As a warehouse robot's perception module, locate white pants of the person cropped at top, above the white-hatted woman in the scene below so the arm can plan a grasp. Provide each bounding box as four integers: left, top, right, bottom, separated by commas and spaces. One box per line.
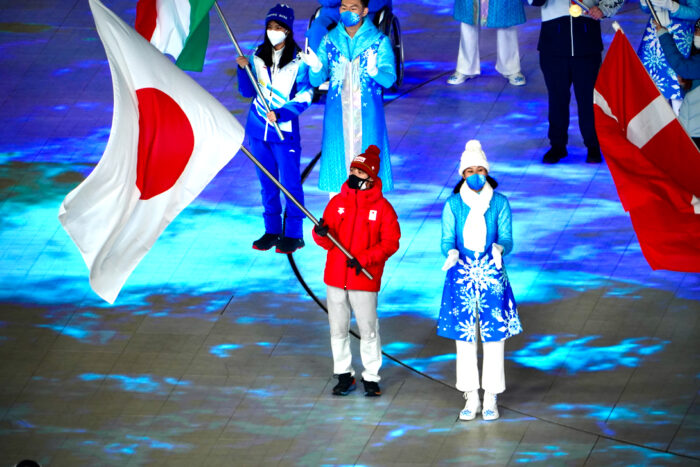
457, 23, 520, 76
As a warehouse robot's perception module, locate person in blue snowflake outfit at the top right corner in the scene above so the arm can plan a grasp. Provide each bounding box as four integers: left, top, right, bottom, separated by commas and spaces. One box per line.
637, 0, 700, 114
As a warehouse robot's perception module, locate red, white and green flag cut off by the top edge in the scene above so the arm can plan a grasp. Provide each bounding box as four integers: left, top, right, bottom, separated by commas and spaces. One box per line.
134, 0, 215, 71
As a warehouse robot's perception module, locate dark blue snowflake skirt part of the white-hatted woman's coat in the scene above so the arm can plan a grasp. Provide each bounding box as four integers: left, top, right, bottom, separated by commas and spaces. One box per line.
437, 250, 523, 342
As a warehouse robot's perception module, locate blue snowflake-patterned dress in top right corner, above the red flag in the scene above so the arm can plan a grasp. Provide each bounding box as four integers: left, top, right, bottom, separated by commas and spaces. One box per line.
637, 18, 695, 99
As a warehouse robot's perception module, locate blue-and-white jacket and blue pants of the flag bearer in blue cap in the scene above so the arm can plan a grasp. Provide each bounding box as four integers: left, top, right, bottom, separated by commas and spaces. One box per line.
238, 50, 313, 238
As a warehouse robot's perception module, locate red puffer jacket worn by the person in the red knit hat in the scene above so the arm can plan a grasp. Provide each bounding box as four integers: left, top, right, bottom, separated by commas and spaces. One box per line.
313, 179, 401, 292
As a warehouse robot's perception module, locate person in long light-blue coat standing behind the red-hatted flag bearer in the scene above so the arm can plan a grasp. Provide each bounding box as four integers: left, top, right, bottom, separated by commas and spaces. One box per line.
302, 0, 396, 193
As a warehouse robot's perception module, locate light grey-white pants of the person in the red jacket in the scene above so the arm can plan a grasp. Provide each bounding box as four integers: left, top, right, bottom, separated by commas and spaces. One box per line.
326, 286, 382, 382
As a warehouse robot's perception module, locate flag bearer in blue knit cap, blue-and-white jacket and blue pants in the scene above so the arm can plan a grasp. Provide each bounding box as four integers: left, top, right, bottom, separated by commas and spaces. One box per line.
236, 4, 313, 253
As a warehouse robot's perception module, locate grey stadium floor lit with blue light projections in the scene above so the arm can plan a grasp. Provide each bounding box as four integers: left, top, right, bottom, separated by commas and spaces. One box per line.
0, 0, 700, 466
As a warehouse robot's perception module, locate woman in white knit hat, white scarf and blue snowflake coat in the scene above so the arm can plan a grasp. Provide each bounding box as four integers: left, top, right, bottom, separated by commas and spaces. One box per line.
437, 140, 522, 420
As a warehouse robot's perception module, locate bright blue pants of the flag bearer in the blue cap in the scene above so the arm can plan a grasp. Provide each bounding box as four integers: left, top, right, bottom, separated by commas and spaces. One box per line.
250, 137, 304, 238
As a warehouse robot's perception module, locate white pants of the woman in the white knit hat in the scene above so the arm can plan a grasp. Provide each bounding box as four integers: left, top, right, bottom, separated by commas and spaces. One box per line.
455, 340, 506, 394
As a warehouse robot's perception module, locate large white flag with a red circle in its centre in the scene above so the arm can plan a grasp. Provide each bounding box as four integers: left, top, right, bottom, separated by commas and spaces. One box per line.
58, 0, 243, 303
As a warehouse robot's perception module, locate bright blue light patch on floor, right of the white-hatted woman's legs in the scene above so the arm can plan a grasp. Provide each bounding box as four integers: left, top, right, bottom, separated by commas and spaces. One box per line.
507, 335, 669, 374
